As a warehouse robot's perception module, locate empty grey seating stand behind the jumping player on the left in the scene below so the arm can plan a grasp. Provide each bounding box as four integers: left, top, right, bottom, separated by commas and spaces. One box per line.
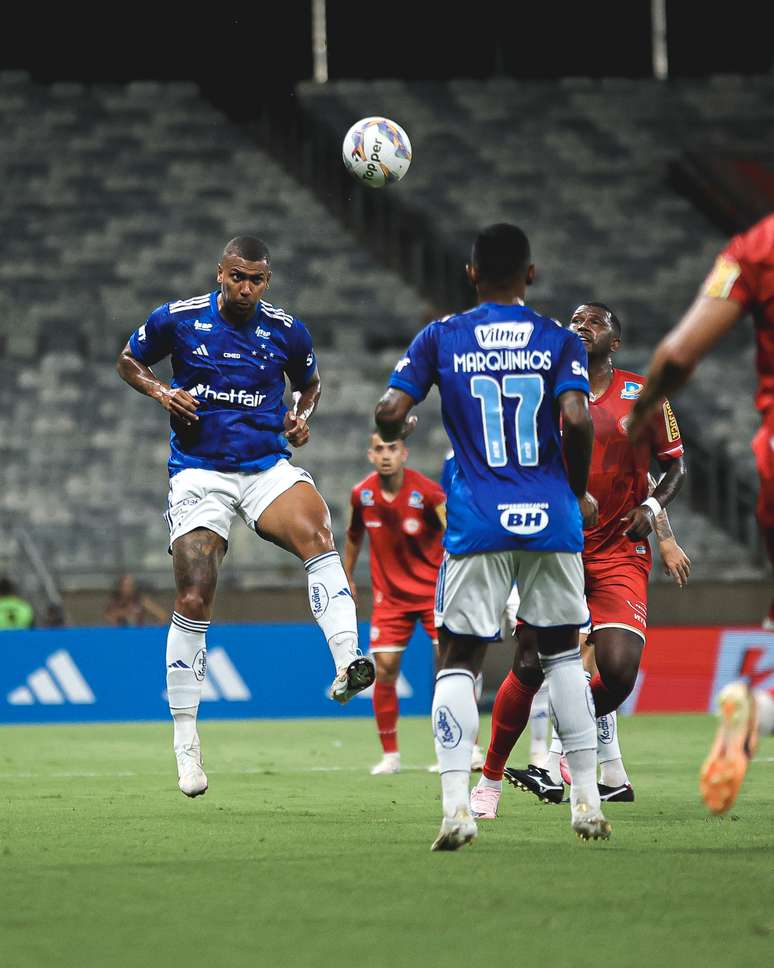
0, 73, 436, 587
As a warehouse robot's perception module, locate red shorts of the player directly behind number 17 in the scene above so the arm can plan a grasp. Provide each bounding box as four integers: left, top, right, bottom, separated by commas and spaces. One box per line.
583, 558, 650, 640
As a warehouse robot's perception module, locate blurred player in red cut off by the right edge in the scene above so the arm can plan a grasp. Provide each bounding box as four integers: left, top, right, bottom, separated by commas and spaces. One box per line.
629, 213, 774, 813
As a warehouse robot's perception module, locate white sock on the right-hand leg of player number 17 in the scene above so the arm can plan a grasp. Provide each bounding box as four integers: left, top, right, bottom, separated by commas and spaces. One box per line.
538, 648, 599, 809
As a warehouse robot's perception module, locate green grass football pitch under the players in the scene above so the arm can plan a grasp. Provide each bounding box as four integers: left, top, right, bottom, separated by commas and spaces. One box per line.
0, 716, 774, 968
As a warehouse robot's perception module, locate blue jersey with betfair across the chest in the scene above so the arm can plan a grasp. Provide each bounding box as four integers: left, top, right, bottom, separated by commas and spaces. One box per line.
129, 291, 317, 476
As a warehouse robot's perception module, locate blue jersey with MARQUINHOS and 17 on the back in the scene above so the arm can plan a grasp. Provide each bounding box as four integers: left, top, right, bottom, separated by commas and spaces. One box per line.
389, 303, 589, 554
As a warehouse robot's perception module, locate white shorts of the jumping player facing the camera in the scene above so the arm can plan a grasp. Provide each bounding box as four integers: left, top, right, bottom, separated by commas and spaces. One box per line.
164, 459, 314, 548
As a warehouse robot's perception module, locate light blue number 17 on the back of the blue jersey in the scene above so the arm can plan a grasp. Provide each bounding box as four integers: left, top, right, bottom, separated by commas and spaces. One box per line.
470, 373, 544, 467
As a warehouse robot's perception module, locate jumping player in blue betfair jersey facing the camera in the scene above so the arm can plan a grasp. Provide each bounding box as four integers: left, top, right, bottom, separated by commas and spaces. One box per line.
117, 236, 375, 797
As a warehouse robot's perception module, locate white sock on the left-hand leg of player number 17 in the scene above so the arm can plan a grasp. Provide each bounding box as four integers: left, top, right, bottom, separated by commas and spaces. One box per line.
433, 669, 478, 817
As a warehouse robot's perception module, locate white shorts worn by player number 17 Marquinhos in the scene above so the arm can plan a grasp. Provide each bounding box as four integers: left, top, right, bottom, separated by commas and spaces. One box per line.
435, 551, 590, 641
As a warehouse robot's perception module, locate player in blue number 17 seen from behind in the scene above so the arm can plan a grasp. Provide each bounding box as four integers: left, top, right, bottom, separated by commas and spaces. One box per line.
375, 224, 610, 850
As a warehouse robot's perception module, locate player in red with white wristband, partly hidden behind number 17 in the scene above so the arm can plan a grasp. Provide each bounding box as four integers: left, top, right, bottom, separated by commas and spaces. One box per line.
472, 303, 690, 819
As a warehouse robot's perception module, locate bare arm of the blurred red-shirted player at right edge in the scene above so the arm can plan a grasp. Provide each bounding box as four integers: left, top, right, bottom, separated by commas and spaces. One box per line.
629, 296, 742, 440
